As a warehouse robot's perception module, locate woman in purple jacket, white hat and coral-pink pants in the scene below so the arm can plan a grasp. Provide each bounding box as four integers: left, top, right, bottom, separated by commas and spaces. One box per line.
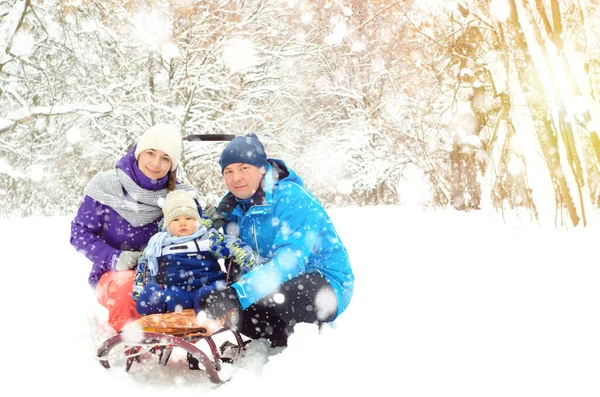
71, 124, 195, 332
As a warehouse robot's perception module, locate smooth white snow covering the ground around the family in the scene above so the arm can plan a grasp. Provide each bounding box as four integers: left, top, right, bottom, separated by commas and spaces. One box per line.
0, 206, 600, 397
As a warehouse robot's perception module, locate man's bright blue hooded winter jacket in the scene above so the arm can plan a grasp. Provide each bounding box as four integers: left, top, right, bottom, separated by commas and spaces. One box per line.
219, 159, 354, 317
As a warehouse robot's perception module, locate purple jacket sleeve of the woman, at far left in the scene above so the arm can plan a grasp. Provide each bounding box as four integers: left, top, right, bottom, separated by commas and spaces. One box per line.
71, 196, 121, 274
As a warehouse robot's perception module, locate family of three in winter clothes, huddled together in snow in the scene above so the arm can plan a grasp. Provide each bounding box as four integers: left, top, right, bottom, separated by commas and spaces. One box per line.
70, 124, 354, 347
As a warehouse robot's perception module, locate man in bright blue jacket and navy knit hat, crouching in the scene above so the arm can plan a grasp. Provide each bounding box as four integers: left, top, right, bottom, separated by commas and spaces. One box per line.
196, 133, 354, 347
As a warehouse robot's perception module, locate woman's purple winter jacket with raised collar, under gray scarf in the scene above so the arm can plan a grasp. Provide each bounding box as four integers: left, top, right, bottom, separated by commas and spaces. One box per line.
71, 146, 168, 288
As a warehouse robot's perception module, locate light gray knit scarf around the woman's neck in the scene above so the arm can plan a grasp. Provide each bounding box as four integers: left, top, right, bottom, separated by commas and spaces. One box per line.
85, 168, 196, 226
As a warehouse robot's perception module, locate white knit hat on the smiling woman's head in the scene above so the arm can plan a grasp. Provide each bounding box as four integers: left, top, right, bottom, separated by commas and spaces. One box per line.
135, 124, 181, 171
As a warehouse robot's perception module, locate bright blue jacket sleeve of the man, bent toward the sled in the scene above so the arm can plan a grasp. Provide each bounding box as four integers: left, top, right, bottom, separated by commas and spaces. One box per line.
232, 183, 324, 309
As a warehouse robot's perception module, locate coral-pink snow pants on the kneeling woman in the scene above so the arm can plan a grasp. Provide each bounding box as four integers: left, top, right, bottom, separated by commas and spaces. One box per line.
96, 270, 141, 332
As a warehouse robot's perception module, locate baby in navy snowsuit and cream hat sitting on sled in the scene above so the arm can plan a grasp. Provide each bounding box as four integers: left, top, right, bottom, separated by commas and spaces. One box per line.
133, 190, 261, 316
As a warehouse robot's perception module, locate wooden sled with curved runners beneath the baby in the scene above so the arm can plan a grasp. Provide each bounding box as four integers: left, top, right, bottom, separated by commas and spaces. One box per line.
97, 309, 245, 383
